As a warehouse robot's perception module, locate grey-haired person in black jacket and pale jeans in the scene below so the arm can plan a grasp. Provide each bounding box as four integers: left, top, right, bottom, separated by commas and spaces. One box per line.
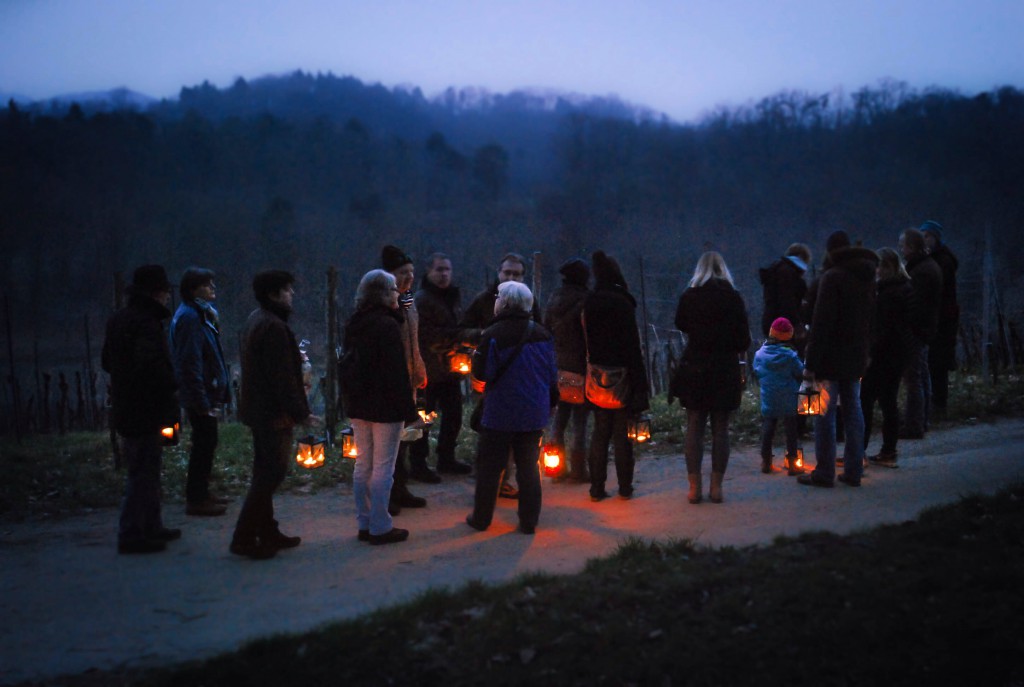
344, 269, 419, 545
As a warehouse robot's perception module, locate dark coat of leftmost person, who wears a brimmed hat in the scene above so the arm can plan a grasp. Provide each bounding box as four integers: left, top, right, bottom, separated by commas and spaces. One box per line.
102, 294, 180, 437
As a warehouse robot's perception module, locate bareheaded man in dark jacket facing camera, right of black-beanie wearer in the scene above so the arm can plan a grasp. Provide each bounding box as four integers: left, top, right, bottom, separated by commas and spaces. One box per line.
409, 253, 482, 483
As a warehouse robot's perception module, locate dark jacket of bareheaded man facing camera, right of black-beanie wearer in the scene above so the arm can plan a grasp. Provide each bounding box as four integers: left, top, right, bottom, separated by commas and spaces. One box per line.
416, 276, 479, 384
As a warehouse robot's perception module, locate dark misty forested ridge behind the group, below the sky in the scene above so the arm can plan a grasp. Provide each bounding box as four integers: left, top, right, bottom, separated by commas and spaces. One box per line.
0, 72, 1024, 364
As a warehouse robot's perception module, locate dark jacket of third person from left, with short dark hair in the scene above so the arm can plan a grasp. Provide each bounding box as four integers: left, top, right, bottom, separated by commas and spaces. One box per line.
239, 303, 309, 429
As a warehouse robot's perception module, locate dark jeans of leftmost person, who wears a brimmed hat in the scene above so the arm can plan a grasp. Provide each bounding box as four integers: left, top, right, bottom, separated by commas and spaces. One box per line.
118, 433, 164, 543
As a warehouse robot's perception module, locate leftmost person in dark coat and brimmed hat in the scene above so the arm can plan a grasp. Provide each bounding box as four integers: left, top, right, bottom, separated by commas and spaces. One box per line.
102, 265, 181, 554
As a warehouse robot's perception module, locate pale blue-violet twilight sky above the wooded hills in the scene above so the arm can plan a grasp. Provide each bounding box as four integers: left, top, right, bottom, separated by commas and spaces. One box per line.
0, 0, 1024, 121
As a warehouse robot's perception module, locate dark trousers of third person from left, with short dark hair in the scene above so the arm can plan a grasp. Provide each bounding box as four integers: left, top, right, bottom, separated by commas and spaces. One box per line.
231, 427, 292, 544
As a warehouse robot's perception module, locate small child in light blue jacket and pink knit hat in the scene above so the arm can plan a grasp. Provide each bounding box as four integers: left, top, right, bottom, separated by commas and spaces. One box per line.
754, 317, 804, 475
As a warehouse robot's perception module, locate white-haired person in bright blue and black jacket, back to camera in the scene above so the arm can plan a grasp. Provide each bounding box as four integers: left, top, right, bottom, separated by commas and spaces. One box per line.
466, 282, 558, 534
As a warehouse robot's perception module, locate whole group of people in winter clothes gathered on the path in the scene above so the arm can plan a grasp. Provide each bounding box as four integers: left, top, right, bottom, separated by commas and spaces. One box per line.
102, 220, 958, 559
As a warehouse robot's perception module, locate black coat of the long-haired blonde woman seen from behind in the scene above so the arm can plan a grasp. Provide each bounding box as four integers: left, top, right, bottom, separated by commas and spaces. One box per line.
676, 278, 751, 411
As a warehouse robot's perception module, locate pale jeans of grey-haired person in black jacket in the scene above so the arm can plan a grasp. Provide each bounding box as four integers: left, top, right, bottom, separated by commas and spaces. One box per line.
352, 419, 404, 534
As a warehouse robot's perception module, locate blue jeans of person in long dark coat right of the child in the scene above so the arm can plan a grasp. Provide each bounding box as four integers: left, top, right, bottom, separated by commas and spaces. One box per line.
812, 379, 864, 482
